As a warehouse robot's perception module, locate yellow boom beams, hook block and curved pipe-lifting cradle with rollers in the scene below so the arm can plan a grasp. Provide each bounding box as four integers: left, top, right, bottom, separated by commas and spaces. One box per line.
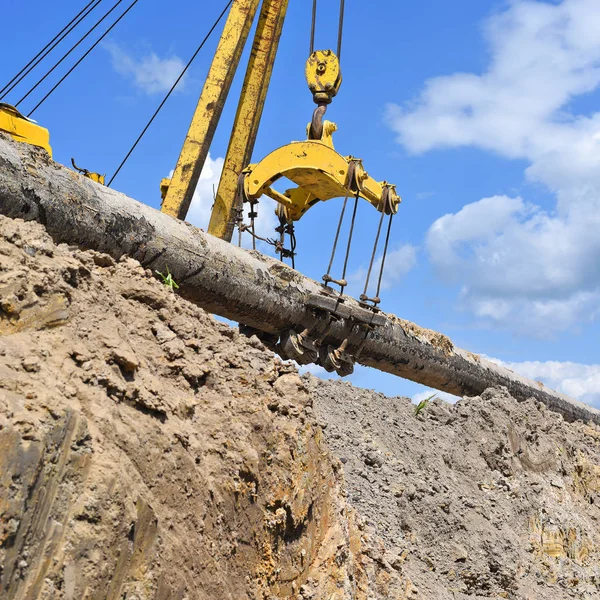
160, 0, 400, 375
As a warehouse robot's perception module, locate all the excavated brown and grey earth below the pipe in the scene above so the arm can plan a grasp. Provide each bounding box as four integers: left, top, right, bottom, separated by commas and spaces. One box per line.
0, 217, 600, 600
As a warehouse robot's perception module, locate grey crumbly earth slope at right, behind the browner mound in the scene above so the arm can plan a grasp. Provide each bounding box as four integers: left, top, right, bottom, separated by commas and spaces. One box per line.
304, 376, 600, 600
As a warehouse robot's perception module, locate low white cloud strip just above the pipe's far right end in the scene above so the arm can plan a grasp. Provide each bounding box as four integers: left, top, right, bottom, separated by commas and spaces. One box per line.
486, 357, 600, 406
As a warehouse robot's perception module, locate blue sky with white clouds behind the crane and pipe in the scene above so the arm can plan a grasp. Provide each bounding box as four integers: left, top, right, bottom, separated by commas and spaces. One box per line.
0, 0, 600, 405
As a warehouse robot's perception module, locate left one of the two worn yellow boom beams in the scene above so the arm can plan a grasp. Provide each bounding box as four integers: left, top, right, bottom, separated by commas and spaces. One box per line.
161, 0, 259, 219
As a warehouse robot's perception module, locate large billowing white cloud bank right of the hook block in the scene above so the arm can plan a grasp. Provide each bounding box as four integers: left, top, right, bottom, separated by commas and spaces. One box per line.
388, 0, 600, 334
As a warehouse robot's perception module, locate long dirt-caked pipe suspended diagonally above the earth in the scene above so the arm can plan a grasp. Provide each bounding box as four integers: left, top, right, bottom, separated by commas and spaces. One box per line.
0, 134, 600, 423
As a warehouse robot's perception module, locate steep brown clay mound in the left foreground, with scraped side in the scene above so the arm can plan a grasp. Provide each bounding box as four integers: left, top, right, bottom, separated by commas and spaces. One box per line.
0, 217, 405, 600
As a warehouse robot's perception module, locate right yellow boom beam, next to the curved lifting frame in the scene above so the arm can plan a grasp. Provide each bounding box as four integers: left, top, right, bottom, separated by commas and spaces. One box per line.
208, 0, 288, 241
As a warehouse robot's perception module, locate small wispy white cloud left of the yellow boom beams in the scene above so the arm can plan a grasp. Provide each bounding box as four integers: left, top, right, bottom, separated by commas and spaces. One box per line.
103, 42, 185, 94
